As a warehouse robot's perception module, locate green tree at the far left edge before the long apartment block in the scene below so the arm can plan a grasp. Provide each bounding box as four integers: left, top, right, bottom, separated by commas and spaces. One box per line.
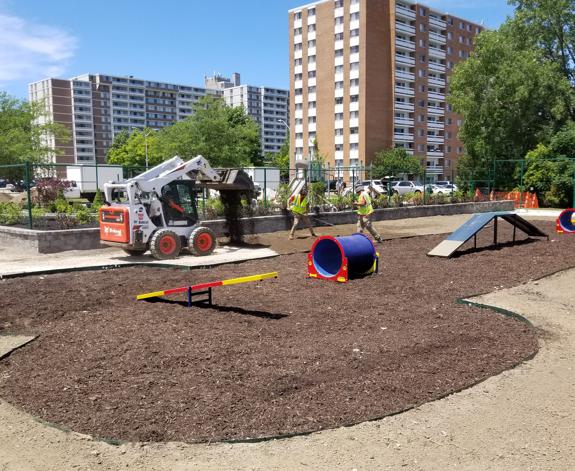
0, 92, 70, 165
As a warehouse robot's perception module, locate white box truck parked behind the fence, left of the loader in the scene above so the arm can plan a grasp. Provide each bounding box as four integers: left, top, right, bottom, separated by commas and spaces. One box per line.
65, 165, 124, 198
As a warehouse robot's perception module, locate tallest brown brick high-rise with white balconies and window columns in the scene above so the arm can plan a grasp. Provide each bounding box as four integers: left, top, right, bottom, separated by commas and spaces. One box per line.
289, 0, 482, 180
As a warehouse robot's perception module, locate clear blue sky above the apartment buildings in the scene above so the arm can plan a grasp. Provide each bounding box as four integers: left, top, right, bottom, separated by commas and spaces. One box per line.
0, 0, 512, 98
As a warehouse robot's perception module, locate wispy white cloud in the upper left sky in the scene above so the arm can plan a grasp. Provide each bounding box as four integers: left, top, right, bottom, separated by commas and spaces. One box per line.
0, 13, 76, 83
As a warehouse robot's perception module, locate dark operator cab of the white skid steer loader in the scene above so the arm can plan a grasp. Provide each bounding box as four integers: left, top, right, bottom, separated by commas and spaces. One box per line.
161, 180, 198, 227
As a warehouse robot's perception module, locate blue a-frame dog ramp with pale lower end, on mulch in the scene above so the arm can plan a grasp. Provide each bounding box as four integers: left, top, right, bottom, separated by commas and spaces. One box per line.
427, 211, 549, 257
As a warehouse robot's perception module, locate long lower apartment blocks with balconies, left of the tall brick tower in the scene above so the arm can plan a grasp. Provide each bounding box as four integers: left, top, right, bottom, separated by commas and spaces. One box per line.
28, 74, 289, 164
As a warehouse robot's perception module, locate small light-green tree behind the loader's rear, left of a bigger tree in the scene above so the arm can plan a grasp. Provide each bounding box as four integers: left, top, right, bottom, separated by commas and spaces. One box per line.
107, 128, 164, 167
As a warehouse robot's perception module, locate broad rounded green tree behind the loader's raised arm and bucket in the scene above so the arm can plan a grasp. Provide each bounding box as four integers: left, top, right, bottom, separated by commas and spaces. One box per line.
159, 96, 262, 167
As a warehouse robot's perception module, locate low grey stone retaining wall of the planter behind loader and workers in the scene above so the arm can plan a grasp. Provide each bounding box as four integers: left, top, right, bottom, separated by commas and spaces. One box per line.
0, 201, 514, 253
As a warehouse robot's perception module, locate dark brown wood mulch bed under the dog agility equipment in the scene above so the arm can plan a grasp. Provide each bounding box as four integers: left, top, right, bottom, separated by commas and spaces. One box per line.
0, 222, 575, 442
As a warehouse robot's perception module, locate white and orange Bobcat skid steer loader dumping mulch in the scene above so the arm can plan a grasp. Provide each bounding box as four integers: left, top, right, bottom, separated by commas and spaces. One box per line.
100, 156, 254, 260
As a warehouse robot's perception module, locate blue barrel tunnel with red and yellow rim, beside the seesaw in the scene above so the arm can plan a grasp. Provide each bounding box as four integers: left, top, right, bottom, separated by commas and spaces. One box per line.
307, 233, 379, 283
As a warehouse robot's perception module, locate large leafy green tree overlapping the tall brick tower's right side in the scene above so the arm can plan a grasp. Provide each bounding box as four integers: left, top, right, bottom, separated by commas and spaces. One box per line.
448, 24, 572, 181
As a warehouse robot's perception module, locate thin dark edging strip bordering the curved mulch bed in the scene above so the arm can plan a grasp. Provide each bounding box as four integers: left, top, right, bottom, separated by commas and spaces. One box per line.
0, 254, 573, 446
